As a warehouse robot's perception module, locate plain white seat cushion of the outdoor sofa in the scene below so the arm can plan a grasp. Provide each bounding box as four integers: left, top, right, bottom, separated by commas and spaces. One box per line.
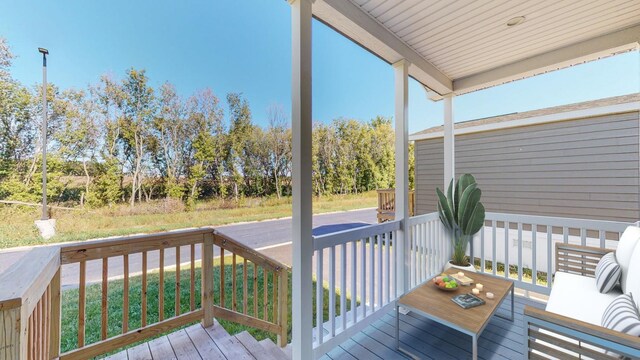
546, 271, 621, 326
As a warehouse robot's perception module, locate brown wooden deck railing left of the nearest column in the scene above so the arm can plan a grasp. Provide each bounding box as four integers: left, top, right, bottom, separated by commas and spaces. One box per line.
0, 228, 289, 360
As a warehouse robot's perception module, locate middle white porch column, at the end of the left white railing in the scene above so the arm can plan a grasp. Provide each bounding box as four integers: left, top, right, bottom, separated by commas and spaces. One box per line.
393, 59, 409, 295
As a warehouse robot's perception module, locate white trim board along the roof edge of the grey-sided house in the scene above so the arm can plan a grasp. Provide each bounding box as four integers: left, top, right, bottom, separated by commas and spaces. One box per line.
409, 101, 640, 141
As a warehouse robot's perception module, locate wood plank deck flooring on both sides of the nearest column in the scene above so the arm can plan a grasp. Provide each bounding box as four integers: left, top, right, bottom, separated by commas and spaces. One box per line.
104, 296, 544, 360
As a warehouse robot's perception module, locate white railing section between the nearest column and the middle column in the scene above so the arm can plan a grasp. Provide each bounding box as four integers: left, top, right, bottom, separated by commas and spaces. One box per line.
313, 221, 400, 358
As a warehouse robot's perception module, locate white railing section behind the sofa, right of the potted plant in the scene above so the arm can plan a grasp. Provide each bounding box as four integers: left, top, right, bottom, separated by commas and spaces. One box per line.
469, 213, 633, 294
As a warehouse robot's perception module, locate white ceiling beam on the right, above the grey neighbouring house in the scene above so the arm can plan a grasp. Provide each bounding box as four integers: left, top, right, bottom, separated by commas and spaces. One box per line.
452, 25, 640, 99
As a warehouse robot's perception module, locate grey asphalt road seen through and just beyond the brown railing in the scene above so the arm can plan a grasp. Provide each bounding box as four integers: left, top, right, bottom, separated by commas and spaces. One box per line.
57, 209, 376, 288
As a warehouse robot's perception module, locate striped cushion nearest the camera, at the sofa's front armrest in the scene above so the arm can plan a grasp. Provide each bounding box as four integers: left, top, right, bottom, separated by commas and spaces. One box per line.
602, 294, 640, 336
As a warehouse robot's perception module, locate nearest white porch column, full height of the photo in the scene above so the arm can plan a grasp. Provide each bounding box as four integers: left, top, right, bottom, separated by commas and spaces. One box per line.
290, 0, 313, 359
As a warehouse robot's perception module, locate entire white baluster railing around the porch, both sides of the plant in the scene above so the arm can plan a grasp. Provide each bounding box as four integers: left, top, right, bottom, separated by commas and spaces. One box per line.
313, 212, 633, 358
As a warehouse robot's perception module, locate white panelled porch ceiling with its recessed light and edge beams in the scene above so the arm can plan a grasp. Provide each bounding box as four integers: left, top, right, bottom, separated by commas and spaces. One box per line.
313, 0, 640, 95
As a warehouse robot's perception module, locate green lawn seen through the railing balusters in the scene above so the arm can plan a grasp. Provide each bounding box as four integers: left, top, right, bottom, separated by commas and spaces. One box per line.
61, 259, 351, 352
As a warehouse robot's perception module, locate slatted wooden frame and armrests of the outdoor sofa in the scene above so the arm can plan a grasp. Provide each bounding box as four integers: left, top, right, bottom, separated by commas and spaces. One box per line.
524, 243, 640, 360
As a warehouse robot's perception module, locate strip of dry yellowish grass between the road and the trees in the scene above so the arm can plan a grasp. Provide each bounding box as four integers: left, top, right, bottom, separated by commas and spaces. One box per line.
0, 191, 377, 248
